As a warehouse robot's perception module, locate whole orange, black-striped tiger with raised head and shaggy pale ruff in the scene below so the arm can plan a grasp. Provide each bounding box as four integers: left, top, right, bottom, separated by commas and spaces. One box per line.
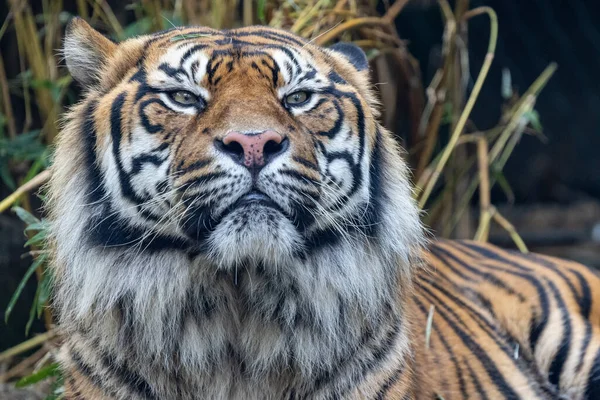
47, 18, 600, 400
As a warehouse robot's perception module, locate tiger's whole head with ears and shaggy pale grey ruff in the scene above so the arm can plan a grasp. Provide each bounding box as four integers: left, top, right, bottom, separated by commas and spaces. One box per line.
49, 19, 423, 388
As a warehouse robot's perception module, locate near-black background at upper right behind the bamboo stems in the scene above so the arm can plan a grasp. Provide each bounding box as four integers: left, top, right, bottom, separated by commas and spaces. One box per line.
396, 0, 600, 204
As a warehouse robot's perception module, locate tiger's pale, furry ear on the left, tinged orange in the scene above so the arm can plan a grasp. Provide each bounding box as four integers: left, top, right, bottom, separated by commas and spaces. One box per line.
63, 17, 117, 87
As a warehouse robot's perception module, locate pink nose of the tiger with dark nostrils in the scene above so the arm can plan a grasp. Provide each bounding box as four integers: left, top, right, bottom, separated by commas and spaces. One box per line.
217, 130, 289, 168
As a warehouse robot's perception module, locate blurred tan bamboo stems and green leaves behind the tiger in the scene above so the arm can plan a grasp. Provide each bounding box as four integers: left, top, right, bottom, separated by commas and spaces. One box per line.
0, 0, 556, 398
